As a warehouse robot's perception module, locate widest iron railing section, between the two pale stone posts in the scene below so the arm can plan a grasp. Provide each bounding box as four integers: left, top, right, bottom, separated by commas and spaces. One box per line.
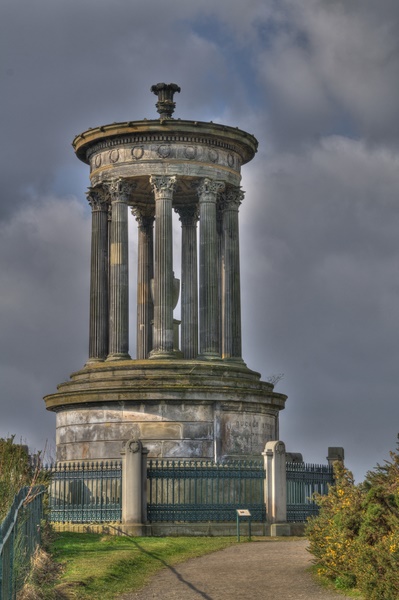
147, 460, 266, 523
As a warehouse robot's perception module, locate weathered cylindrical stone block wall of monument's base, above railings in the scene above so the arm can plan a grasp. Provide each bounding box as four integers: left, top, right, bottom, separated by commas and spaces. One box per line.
56, 402, 277, 461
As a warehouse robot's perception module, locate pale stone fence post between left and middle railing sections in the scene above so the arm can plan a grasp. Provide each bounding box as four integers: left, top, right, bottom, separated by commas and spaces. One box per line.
121, 439, 143, 535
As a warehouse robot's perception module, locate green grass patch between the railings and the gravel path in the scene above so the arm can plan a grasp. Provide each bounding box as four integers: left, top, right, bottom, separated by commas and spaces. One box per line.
50, 533, 235, 600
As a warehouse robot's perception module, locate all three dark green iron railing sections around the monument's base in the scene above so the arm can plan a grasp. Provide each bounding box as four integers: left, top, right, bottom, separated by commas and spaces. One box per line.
46, 459, 334, 523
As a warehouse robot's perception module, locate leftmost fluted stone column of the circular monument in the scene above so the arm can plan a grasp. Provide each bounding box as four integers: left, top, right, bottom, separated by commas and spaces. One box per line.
87, 187, 109, 364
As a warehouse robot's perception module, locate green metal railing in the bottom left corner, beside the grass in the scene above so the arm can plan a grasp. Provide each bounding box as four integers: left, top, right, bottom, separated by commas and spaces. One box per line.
0, 486, 46, 600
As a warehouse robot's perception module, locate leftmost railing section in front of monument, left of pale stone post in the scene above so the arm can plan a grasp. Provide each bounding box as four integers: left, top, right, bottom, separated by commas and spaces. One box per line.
44, 461, 122, 523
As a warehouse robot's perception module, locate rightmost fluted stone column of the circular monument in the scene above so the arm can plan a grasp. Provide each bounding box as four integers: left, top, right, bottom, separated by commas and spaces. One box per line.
222, 189, 244, 362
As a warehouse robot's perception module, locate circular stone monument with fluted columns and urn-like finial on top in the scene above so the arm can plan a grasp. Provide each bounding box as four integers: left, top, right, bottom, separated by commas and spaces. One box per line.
45, 83, 286, 461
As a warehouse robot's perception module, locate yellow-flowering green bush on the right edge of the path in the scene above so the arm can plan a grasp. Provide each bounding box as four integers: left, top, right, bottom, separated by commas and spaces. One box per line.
307, 453, 399, 600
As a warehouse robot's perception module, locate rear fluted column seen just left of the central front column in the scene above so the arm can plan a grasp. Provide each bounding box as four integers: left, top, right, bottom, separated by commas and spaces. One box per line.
132, 205, 154, 360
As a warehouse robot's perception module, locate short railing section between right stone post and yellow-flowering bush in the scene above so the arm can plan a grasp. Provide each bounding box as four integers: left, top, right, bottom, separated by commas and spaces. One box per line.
286, 463, 334, 523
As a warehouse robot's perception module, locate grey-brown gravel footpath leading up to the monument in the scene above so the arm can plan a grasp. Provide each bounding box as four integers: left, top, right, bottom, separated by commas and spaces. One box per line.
120, 539, 356, 600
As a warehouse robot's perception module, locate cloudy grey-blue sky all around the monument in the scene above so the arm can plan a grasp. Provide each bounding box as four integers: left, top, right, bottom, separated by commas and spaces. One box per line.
0, 0, 399, 481
